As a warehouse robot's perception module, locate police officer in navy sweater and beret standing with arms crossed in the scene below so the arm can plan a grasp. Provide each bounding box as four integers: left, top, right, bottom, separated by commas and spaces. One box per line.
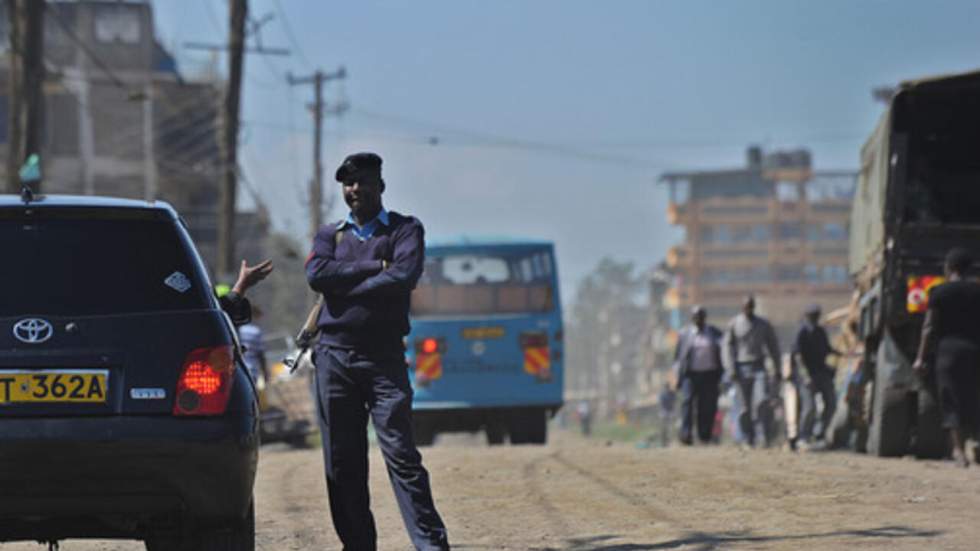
306, 153, 449, 551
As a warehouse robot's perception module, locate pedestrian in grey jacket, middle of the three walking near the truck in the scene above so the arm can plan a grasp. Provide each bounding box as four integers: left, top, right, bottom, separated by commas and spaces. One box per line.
725, 295, 782, 446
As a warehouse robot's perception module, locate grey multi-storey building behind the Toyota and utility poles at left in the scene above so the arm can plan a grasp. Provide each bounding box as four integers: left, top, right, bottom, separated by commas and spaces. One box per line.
0, 0, 268, 272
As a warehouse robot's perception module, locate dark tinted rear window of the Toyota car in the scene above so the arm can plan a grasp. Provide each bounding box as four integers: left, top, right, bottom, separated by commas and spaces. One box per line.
0, 209, 209, 316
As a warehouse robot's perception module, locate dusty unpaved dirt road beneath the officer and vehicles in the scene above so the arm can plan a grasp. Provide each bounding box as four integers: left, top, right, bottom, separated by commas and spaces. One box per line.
0, 433, 980, 551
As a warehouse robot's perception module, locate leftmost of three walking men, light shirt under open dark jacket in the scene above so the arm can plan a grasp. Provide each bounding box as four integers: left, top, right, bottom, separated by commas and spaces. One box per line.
674, 306, 724, 445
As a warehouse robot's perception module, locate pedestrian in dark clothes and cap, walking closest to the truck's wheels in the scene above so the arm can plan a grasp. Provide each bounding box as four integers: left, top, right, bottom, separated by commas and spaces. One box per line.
790, 304, 841, 445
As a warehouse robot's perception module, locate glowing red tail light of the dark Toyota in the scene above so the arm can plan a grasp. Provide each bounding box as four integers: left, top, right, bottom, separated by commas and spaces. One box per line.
174, 346, 235, 415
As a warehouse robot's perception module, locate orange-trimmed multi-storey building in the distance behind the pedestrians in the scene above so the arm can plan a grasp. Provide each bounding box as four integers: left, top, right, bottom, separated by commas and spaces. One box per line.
660, 147, 856, 343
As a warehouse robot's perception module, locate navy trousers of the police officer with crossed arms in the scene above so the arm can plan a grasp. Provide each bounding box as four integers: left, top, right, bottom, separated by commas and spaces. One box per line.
314, 343, 449, 551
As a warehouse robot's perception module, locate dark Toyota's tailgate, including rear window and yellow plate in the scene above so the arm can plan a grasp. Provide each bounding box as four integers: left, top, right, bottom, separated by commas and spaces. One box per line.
0, 206, 224, 418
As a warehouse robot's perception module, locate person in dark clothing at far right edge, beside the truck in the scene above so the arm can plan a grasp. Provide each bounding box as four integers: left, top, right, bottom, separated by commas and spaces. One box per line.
913, 249, 980, 467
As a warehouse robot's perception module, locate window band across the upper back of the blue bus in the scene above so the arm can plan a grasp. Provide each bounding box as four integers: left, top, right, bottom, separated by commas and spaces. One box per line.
412, 249, 555, 316
